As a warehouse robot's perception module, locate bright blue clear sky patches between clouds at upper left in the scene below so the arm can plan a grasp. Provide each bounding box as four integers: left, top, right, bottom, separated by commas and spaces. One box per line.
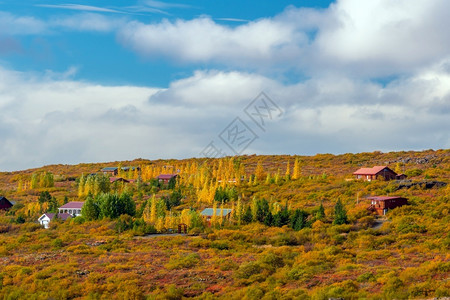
0, 1, 331, 87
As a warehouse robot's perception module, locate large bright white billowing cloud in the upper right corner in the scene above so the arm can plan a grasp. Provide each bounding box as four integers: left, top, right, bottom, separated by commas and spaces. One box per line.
314, 0, 450, 76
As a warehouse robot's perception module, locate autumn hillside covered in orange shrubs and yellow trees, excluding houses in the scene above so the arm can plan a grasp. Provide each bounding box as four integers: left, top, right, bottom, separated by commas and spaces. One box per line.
0, 149, 450, 299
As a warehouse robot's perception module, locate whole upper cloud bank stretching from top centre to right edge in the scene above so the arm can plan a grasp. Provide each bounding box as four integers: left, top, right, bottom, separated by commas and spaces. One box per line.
119, 0, 450, 77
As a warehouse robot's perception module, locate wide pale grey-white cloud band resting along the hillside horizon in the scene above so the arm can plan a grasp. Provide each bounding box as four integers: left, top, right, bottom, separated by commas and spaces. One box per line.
0, 62, 450, 170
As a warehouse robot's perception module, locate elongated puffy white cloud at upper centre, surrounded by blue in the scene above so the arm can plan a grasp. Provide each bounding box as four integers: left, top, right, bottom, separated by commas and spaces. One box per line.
119, 17, 307, 65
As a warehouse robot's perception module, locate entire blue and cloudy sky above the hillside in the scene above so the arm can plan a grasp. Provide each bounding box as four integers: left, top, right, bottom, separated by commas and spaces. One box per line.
0, 0, 450, 171
